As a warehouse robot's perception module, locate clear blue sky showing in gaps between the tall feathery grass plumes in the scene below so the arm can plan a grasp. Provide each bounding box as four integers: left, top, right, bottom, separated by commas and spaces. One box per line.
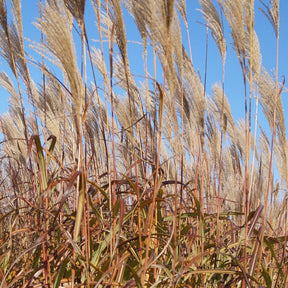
0, 0, 288, 130
